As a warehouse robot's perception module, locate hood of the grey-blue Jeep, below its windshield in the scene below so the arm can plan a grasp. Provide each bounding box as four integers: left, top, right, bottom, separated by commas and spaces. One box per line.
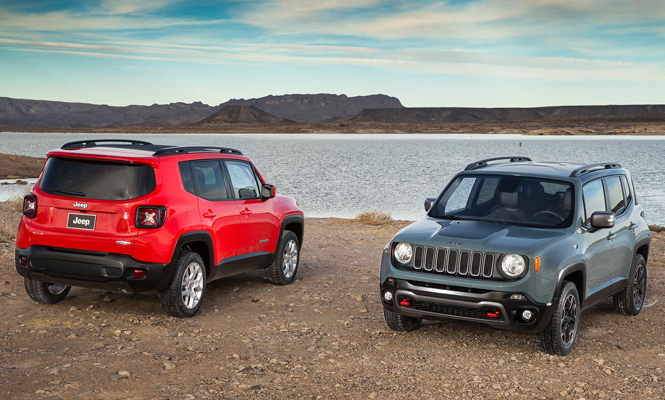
393, 217, 565, 254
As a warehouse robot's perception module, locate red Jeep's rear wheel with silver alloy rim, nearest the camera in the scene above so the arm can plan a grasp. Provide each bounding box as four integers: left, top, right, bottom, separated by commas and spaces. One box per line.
159, 250, 206, 318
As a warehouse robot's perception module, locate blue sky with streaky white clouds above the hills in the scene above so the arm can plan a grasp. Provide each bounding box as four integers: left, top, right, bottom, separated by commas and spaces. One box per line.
0, 0, 665, 107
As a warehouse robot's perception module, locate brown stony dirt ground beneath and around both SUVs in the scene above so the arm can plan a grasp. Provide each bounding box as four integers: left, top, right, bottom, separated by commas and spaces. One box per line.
0, 209, 665, 400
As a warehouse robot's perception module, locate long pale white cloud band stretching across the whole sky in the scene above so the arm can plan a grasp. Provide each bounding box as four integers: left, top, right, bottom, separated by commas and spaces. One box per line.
0, 39, 665, 81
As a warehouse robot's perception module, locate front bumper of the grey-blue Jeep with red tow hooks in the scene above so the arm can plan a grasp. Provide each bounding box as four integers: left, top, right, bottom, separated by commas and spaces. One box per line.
381, 278, 554, 332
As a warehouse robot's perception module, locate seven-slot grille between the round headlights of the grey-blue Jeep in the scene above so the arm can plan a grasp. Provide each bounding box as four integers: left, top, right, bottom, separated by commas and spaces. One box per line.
413, 245, 497, 278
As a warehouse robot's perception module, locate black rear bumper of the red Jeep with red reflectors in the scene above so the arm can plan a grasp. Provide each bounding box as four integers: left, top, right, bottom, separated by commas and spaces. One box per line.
14, 246, 173, 292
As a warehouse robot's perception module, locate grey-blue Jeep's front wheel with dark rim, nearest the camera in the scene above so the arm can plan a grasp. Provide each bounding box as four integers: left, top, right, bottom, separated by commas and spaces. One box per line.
540, 281, 580, 356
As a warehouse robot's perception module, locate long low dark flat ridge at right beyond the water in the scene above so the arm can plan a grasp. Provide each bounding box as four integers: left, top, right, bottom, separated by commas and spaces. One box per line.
349, 105, 665, 123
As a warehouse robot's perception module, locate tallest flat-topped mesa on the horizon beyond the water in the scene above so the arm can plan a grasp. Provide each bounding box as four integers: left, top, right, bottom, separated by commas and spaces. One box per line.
221, 93, 403, 122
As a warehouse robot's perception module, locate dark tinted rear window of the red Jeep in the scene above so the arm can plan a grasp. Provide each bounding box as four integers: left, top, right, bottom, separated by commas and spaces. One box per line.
39, 157, 155, 200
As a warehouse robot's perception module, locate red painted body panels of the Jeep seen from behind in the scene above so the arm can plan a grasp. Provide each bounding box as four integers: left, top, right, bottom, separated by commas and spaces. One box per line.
16, 147, 303, 278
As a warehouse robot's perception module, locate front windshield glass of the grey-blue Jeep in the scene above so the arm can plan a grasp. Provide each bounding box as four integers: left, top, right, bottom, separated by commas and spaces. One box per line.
429, 175, 575, 228
